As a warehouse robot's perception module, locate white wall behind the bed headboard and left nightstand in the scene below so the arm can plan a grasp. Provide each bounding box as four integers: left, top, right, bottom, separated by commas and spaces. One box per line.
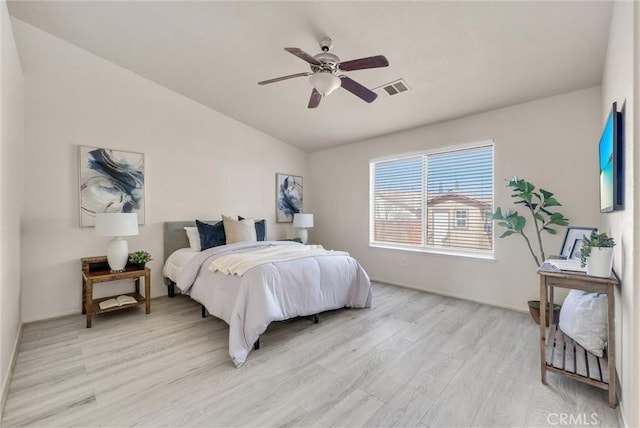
13, 20, 306, 321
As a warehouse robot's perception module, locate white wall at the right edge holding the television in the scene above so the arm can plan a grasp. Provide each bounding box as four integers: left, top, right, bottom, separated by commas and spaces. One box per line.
600, 2, 640, 426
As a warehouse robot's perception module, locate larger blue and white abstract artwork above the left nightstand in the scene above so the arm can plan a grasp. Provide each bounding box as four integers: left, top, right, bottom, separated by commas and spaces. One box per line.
78, 146, 145, 227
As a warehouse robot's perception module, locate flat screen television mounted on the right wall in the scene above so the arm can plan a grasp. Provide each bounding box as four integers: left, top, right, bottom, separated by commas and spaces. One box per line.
599, 103, 624, 213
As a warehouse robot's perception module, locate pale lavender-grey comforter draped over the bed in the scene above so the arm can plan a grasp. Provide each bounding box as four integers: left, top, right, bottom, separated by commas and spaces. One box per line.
177, 241, 371, 367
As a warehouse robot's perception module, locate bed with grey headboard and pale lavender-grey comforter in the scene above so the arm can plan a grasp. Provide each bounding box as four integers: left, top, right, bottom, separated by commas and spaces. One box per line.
163, 221, 372, 367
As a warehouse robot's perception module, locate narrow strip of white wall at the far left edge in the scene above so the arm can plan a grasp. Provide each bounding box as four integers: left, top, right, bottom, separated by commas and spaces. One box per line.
0, 1, 24, 413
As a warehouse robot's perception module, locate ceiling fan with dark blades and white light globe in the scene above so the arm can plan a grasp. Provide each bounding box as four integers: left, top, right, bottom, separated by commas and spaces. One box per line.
258, 37, 389, 108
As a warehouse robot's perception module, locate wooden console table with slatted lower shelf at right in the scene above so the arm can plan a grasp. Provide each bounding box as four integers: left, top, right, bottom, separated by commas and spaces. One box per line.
538, 263, 619, 408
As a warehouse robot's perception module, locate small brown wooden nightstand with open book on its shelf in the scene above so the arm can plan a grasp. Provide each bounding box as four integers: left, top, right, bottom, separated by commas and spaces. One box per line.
80, 256, 151, 328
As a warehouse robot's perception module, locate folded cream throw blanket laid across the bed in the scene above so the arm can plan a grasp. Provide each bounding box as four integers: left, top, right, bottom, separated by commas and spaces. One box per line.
209, 245, 349, 276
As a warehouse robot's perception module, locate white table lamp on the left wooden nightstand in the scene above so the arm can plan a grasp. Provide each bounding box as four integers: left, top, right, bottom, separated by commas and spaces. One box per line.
96, 213, 138, 272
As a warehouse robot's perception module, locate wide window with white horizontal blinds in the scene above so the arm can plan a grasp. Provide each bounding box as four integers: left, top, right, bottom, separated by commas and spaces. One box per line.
370, 142, 493, 253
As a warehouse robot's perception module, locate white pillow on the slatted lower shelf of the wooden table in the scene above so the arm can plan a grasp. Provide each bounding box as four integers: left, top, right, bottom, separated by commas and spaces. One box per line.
559, 290, 607, 357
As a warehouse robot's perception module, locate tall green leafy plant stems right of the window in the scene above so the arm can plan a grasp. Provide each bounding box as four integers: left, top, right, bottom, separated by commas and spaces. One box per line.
492, 177, 569, 269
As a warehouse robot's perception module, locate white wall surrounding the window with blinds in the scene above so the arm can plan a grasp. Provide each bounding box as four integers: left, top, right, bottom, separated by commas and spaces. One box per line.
309, 87, 601, 310
